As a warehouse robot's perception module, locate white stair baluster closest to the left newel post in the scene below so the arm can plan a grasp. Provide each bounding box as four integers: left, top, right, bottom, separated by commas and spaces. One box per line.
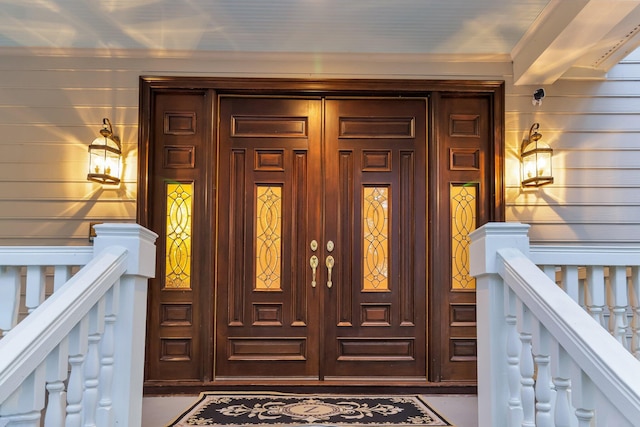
96, 280, 120, 427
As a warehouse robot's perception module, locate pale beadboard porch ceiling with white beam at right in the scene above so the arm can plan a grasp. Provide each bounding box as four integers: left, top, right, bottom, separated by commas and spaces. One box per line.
0, 0, 640, 84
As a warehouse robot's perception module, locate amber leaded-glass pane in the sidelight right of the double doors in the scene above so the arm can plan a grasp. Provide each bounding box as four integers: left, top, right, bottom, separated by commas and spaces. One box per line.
450, 184, 478, 290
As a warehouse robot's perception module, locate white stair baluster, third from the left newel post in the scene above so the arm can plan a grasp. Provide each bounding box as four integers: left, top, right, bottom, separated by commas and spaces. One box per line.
65, 316, 89, 427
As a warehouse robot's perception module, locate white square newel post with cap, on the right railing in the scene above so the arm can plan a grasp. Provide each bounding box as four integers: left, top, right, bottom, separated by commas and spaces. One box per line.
469, 222, 529, 427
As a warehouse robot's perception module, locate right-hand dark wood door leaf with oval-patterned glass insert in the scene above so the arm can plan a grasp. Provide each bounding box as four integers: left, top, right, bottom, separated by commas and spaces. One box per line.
323, 98, 427, 379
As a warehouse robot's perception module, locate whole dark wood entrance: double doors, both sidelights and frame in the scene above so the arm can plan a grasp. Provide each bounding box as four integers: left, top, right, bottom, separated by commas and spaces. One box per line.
138, 77, 504, 391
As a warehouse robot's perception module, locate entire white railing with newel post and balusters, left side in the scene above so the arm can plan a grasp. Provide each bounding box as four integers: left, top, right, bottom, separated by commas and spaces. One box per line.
0, 224, 157, 427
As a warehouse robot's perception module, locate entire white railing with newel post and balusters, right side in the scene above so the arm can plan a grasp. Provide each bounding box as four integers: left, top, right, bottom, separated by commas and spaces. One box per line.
470, 223, 640, 427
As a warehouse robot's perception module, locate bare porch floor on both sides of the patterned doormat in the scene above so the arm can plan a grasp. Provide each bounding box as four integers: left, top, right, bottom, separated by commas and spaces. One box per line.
142, 394, 478, 427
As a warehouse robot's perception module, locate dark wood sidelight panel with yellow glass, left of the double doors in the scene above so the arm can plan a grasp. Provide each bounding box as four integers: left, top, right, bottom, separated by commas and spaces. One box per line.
145, 90, 211, 381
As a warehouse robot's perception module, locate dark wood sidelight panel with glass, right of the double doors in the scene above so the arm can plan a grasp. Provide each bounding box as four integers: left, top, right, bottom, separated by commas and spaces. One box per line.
431, 94, 493, 381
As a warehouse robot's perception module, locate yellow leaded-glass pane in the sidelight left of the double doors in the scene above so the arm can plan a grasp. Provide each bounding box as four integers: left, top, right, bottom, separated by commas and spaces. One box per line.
164, 182, 193, 289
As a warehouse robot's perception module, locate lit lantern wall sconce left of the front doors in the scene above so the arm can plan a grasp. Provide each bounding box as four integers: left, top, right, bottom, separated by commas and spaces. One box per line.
87, 118, 122, 184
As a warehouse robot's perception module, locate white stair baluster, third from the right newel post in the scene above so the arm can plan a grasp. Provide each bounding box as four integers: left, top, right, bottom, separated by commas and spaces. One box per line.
533, 323, 553, 427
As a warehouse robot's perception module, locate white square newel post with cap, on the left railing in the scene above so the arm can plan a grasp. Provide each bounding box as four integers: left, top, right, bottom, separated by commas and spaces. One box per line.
93, 224, 158, 426
